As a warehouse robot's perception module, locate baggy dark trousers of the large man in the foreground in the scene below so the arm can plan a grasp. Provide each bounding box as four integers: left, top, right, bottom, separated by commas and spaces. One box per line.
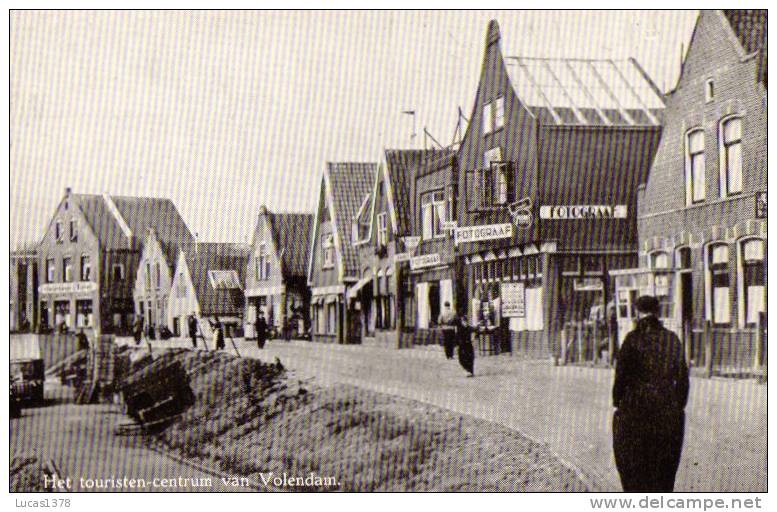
612, 410, 685, 492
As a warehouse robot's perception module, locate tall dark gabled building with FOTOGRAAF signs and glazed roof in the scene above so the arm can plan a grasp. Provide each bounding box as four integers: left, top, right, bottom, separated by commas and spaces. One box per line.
455, 21, 664, 356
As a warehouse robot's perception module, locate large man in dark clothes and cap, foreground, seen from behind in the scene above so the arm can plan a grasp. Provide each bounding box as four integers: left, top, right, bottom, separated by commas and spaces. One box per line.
612, 296, 689, 492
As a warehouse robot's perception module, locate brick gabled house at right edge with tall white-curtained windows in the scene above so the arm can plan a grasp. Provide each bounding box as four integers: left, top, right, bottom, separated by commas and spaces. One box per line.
617, 10, 767, 368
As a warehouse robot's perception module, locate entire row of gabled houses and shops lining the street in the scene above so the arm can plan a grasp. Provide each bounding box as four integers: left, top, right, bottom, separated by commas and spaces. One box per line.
12, 11, 767, 372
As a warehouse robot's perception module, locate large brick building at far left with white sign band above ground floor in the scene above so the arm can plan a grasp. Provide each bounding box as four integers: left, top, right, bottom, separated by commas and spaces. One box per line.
38, 188, 191, 333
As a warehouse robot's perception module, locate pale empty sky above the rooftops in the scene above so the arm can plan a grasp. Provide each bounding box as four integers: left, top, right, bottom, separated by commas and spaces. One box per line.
10, 11, 696, 247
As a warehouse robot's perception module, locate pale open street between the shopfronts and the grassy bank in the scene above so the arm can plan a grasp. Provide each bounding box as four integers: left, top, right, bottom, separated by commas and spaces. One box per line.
209, 341, 767, 491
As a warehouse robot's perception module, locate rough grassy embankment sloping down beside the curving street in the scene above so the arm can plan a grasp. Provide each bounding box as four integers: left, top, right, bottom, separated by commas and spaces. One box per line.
142, 352, 585, 491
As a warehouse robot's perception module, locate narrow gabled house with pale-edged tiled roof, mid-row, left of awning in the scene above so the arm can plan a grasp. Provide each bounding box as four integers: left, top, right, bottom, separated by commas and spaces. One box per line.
307, 162, 377, 343
